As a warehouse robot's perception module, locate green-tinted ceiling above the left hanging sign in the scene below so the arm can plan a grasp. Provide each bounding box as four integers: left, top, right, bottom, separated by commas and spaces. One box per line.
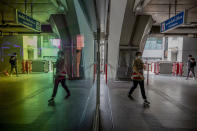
0, 0, 59, 24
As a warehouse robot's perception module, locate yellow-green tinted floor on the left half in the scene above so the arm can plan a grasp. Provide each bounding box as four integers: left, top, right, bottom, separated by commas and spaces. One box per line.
0, 74, 95, 131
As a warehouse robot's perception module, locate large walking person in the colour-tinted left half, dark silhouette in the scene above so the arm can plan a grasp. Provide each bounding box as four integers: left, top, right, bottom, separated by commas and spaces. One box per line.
48, 51, 70, 102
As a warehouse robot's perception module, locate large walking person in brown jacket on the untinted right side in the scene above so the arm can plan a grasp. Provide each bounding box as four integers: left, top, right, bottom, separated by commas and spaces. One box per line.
128, 52, 150, 104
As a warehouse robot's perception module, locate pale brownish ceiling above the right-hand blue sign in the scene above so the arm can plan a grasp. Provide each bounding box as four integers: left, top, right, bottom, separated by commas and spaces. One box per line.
143, 0, 197, 25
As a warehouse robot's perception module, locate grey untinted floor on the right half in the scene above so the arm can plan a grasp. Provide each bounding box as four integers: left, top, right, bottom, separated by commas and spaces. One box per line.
102, 75, 197, 131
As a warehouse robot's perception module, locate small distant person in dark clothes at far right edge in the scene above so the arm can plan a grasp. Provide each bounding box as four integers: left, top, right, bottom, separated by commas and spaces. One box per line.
186, 55, 196, 80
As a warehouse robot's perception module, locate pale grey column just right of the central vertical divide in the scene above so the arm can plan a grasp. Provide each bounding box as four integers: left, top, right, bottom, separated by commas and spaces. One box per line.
108, 0, 127, 80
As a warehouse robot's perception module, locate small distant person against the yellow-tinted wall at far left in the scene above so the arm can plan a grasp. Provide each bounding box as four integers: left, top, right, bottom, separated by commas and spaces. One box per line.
9, 53, 18, 76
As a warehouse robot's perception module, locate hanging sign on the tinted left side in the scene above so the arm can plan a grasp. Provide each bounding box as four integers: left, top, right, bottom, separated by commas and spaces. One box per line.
16, 11, 41, 32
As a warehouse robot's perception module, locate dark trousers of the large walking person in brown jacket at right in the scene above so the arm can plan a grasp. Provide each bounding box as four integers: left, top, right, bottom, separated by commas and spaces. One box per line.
129, 80, 146, 99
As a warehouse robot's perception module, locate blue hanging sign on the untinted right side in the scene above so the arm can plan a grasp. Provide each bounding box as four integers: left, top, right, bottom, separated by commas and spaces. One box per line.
160, 11, 185, 32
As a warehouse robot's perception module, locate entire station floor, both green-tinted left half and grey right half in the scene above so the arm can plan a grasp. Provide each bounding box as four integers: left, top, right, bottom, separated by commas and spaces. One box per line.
0, 74, 197, 131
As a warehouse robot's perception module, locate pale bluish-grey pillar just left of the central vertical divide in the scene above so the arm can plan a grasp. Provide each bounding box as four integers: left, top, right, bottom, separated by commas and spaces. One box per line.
74, 0, 96, 79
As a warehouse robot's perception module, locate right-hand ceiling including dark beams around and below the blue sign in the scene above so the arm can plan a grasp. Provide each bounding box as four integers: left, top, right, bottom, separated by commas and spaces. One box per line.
141, 0, 197, 35
